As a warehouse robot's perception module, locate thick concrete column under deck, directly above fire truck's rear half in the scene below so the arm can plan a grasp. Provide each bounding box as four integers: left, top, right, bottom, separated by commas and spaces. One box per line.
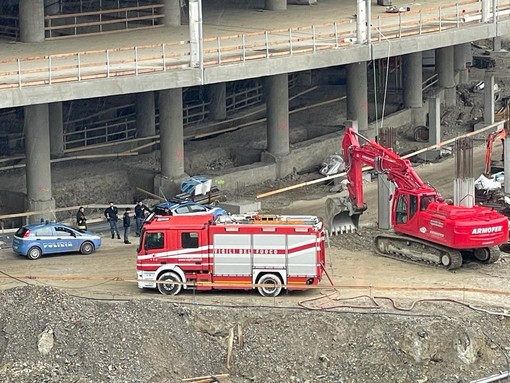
264, 73, 290, 156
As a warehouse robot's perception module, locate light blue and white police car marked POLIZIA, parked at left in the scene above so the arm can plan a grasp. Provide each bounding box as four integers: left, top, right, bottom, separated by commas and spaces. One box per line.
12, 222, 101, 259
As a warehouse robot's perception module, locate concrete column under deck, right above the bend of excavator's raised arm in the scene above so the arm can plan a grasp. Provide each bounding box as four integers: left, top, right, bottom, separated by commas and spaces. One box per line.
347, 62, 368, 132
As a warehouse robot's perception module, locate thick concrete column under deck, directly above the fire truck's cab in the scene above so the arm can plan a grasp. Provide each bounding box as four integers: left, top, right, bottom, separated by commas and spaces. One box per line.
159, 88, 184, 180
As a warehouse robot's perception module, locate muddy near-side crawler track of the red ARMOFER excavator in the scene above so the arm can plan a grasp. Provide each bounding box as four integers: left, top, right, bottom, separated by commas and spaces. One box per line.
374, 234, 462, 270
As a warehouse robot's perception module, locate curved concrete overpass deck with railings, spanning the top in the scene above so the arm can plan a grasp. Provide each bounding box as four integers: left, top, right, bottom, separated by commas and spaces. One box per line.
0, 0, 510, 108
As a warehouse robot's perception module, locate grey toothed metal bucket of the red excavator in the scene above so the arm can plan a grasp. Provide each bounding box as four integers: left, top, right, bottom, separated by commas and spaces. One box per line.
325, 197, 362, 235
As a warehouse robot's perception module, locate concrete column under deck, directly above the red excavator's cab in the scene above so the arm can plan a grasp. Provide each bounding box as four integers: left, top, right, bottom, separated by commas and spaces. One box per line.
403, 52, 423, 108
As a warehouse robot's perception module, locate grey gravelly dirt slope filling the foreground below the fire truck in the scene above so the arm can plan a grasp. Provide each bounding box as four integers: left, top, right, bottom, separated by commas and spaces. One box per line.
0, 286, 510, 383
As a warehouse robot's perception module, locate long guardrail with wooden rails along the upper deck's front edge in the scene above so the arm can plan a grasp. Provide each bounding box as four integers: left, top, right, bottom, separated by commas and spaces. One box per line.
0, 1, 502, 89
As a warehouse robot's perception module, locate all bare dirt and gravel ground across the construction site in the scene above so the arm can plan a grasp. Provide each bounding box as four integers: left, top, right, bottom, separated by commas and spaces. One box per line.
0, 40, 510, 383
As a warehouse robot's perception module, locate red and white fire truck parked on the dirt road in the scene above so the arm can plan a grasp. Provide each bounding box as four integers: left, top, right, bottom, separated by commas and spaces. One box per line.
137, 214, 325, 297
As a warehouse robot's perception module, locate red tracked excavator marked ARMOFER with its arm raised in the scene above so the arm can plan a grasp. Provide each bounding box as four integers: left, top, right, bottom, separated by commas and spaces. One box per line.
326, 129, 508, 270
